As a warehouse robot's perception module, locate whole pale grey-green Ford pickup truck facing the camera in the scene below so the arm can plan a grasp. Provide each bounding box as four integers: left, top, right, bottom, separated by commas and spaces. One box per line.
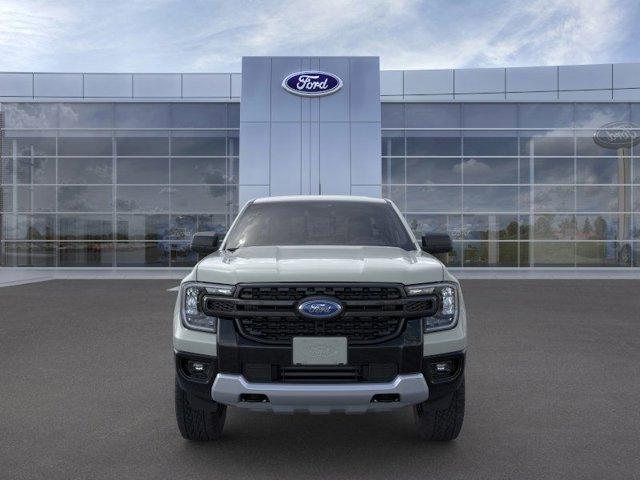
173, 196, 467, 441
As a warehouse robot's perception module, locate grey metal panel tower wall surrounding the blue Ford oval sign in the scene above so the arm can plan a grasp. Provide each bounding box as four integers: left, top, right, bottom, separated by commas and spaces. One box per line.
240, 57, 381, 205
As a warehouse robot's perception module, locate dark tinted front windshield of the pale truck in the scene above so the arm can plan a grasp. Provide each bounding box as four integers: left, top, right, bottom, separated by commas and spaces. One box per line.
225, 201, 416, 250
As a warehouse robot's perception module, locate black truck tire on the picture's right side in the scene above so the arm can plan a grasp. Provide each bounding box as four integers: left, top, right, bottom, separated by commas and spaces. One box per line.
413, 379, 464, 442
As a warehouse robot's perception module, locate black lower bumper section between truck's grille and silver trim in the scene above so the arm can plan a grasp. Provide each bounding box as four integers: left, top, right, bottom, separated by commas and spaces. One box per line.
176, 319, 465, 403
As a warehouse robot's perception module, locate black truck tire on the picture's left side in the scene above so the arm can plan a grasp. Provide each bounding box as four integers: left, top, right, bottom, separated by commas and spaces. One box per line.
176, 380, 227, 442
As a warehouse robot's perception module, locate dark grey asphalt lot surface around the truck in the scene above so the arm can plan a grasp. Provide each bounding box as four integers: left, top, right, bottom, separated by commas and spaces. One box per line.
0, 280, 640, 480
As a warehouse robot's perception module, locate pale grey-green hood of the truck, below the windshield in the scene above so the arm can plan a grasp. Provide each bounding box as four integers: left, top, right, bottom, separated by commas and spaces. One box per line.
196, 246, 444, 285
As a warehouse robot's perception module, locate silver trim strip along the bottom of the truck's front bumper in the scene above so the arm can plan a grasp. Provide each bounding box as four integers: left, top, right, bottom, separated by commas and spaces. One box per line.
211, 373, 429, 413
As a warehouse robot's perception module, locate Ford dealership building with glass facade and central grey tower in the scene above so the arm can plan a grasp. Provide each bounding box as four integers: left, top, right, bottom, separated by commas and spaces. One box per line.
0, 57, 640, 269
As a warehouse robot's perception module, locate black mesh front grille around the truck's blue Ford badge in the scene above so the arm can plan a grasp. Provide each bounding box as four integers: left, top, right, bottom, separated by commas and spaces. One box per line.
202, 284, 438, 344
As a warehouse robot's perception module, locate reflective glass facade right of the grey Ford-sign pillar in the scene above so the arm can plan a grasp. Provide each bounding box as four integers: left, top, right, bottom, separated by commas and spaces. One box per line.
382, 103, 640, 267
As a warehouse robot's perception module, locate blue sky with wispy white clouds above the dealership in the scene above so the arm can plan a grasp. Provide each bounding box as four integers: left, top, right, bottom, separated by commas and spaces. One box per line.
0, 0, 640, 72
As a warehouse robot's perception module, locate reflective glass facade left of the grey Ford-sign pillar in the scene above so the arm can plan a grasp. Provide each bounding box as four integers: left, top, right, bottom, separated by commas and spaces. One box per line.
0, 103, 239, 267
